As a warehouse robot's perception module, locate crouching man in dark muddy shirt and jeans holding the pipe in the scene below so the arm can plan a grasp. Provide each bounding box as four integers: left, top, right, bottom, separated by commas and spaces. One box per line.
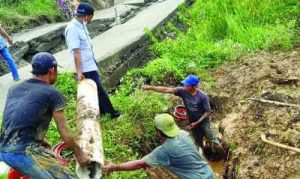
0, 52, 90, 179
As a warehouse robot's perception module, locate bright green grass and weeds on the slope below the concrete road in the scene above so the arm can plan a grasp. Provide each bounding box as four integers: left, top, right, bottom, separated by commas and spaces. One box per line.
36, 0, 300, 178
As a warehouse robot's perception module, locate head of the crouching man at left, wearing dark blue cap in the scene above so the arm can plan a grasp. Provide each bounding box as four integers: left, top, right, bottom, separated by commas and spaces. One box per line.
31, 52, 57, 84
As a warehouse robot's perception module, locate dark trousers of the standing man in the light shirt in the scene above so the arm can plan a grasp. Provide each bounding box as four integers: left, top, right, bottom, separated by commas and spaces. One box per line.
83, 71, 115, 115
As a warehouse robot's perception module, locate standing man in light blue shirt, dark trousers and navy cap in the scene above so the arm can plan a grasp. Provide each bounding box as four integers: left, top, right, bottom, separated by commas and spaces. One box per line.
65, 3, 120, 118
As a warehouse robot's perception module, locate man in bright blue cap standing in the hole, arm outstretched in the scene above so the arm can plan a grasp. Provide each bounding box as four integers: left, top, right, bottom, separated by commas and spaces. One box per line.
143, 75, 221, 149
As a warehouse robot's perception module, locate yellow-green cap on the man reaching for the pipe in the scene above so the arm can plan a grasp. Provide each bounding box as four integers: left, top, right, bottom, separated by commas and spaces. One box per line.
154, 114, 179, 137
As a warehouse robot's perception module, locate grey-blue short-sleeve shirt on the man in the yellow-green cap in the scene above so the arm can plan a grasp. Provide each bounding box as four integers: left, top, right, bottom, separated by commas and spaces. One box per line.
143, 130, 213, 179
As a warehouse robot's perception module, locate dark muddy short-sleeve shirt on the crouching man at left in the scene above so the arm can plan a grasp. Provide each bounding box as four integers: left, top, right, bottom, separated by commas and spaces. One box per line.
0, 79, 66, 154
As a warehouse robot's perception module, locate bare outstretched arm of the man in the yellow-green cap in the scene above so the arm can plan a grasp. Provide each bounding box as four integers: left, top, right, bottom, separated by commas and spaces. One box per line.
102, 159, 150, 173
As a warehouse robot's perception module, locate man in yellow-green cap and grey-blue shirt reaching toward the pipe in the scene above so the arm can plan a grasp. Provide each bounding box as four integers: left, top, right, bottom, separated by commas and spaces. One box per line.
103, 114, 214, 179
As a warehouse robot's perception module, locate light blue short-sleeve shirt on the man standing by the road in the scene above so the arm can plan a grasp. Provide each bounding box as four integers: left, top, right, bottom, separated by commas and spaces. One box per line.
65, 18, 98, 73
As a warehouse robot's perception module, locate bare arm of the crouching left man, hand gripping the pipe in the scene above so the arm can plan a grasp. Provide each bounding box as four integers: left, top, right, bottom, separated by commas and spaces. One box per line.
53, 110, 91, 165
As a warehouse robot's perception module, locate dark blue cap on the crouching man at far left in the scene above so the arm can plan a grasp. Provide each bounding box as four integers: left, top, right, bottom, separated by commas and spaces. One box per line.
31, 52, 57, 75
